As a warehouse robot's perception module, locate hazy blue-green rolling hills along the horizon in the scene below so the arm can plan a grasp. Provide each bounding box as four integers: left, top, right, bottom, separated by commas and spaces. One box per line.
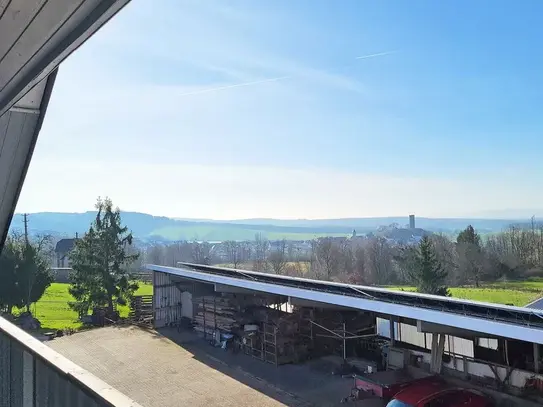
12, 211, 532, 241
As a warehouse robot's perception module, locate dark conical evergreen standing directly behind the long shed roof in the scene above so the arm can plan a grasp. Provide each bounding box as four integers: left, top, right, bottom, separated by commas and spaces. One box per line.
408, 236, 450, 296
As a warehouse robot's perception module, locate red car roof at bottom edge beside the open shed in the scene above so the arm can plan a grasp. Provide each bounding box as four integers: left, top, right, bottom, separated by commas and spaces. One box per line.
387, 382, 493, 407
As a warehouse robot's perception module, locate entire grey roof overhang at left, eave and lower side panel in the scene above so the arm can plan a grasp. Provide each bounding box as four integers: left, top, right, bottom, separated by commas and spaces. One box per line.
0, 0, 130, 250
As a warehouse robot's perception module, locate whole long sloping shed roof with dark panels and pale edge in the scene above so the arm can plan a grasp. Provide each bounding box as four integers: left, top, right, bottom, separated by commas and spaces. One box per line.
146, 264, 543, 344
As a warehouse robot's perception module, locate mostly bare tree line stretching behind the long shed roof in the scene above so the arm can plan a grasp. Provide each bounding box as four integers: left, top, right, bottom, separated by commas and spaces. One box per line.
145, 222, 543, 295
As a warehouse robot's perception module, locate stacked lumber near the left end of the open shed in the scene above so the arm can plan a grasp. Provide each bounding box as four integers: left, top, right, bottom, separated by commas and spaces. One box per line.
194, 296, 240, 334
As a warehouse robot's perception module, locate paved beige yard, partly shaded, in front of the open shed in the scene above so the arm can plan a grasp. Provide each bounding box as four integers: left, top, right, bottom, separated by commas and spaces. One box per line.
47, 327, 382, 407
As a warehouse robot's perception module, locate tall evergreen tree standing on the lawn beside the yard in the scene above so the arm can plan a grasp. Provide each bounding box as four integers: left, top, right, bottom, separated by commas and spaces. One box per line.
70, 198, 138, 315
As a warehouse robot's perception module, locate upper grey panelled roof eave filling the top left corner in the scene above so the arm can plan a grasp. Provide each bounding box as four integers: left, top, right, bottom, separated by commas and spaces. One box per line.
0, 0, 129, 116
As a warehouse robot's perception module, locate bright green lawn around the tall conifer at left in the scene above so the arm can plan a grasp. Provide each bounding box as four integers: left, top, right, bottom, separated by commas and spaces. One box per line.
24, 283, 153, 330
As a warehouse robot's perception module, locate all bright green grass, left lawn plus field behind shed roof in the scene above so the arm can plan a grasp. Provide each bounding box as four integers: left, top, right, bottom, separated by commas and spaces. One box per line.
26, 279, 543, 330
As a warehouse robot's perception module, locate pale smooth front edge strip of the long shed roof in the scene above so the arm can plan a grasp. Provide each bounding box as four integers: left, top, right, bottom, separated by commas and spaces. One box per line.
145, 265, 543, 344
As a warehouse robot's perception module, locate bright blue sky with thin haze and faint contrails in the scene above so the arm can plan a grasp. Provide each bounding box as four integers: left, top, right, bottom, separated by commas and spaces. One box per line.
12, 0, 543, 219
